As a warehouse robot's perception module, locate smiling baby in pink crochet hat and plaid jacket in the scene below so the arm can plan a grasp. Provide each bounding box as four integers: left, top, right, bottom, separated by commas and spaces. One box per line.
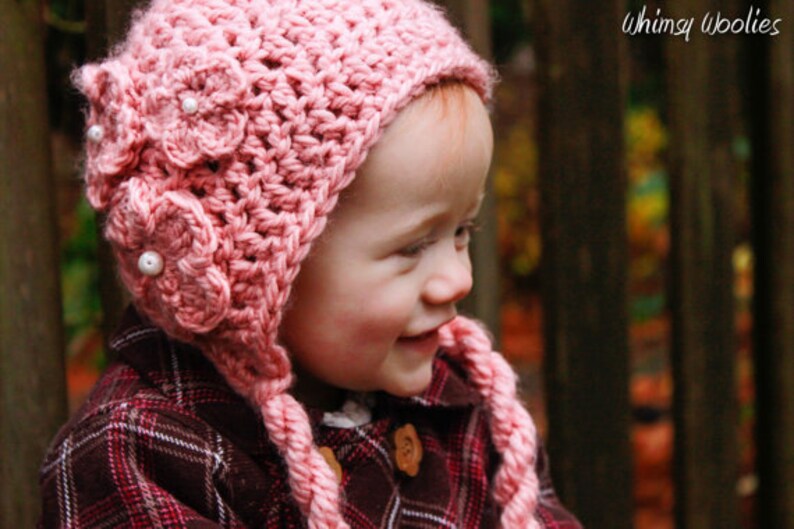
41, 0, 580, 528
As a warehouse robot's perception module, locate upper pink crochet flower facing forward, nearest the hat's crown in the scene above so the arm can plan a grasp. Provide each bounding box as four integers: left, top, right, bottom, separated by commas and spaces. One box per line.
143, 49, 248, 169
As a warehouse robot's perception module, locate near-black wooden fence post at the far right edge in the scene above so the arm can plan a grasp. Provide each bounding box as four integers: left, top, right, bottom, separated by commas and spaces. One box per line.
749, 0, 794, 529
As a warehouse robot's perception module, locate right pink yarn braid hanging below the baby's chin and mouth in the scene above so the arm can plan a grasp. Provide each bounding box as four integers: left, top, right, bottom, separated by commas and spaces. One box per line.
441, 317, 540, 529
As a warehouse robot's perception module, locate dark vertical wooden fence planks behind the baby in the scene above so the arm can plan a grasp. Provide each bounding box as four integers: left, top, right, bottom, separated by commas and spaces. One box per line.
0, 0, 794, 529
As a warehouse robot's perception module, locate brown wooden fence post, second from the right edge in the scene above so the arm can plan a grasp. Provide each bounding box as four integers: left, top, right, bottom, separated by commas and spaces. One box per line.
665, 0, 739, 529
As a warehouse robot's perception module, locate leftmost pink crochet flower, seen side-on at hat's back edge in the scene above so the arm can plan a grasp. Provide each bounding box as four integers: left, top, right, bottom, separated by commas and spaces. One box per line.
75, 61, 143, 210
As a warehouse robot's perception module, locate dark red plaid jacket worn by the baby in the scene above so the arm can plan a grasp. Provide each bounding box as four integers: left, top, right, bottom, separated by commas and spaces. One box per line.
40, 311, 580, 529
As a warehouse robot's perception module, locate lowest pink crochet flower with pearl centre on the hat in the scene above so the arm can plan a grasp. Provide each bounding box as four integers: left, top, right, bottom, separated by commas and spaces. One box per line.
105, 178, 230, 338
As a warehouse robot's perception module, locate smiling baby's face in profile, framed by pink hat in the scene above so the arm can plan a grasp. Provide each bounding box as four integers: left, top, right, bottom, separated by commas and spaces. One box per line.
281, 87, 493, 405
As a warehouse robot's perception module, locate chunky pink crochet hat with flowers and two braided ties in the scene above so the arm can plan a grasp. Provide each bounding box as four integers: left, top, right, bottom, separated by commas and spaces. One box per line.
75, 0, 538, 528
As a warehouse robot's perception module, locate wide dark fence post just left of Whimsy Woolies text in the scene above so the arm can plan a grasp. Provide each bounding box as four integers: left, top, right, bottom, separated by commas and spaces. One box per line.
534, 0, 633, 529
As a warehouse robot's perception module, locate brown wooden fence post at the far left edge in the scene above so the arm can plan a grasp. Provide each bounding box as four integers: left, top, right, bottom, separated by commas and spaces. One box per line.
0, 0, 66, 528
